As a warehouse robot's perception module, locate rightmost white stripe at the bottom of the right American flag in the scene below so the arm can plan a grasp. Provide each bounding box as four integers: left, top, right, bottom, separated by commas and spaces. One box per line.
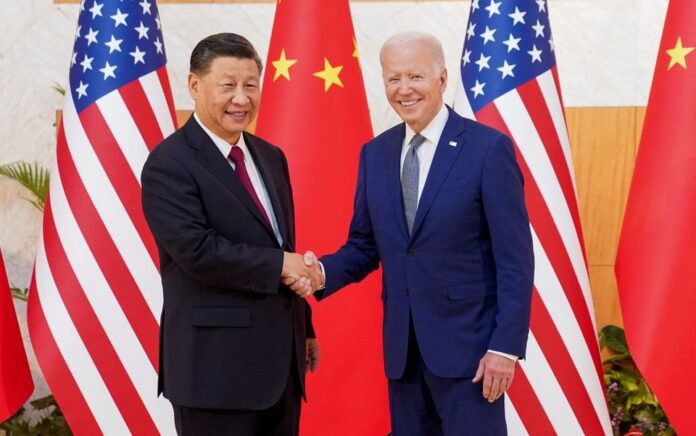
532, 229, 611, 433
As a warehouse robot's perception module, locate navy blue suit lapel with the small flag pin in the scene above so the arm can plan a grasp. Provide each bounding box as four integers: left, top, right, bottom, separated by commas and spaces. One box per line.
410, 108, 465, 239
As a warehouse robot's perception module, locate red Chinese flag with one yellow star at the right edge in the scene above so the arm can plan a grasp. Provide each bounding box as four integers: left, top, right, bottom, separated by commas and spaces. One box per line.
616, 0, 696, 434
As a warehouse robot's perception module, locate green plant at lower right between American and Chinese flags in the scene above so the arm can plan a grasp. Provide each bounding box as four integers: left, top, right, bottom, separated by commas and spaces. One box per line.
599, 325, 676, 436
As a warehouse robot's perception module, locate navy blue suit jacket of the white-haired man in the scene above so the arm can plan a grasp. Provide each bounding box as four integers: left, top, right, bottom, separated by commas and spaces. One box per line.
318, 109, 534, 379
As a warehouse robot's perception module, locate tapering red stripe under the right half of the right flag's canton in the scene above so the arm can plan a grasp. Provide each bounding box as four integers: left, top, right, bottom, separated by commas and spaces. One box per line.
517, 80, 587, 260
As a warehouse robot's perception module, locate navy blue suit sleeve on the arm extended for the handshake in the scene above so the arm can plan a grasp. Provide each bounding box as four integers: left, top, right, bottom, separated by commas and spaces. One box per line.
314, 146, 380, 300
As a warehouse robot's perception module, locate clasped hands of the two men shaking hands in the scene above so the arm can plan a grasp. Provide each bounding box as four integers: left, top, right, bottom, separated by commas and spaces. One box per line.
280, 251, 325, 298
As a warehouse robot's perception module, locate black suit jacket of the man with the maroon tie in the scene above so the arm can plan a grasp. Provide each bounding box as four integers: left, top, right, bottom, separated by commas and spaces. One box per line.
142, 117, 314, 410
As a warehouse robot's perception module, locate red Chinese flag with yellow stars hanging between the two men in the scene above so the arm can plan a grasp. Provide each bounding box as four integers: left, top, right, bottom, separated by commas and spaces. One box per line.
256, 0, 389, 436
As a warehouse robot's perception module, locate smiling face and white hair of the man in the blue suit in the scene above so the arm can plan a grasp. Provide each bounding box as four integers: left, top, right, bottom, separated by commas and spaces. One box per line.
380, 39, 447, 133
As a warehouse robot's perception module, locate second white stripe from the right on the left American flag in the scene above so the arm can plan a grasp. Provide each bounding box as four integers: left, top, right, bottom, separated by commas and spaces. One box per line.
96, 90, 150, 184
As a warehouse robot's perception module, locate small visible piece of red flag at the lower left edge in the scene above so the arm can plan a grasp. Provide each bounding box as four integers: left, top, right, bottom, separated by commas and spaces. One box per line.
0, 250, 34, 422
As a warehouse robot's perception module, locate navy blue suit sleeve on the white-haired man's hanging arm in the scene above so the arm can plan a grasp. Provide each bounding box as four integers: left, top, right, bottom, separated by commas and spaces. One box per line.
481, 135, 534, 358
